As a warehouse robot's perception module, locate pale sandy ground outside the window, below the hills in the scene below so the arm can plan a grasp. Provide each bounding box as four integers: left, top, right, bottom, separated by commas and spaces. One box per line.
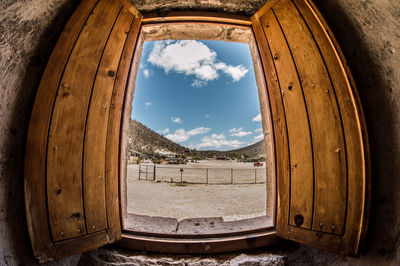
127, 161, 266, 221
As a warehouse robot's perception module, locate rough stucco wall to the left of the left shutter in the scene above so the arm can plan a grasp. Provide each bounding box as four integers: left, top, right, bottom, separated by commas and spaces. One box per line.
0, 0, 79, 265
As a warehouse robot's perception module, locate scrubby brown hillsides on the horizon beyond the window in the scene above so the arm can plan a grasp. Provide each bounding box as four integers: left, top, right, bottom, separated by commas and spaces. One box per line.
128, 120, 265, 158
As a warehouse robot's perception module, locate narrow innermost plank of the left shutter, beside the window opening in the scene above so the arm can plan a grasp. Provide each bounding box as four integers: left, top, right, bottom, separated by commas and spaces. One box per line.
105, 8, 142, 243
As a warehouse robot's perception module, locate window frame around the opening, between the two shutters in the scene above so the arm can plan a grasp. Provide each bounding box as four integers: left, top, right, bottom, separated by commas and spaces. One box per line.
117, 12, 279, 254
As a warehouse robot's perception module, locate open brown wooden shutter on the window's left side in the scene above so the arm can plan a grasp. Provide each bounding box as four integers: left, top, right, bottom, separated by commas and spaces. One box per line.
25, 0, 142, 263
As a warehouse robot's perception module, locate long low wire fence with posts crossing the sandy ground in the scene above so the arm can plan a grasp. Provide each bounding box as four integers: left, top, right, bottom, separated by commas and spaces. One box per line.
139, 165, 266, 185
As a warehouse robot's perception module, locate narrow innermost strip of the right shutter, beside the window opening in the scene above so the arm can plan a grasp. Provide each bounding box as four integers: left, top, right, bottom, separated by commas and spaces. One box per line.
251, 13, 290, 237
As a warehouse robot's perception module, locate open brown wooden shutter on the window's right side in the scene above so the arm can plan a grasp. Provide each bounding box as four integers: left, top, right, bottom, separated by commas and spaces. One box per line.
252, 0, 369, 255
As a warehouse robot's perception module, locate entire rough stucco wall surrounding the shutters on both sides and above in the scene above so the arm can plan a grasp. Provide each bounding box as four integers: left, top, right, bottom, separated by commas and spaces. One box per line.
0, 0, 400, 265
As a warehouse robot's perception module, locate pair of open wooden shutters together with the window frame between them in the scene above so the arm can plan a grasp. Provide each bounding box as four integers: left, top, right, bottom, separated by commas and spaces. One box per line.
25, 0, 370, 262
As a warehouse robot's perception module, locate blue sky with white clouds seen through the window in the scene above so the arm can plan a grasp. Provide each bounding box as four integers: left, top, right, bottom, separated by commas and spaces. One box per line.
131, 40, 262, 150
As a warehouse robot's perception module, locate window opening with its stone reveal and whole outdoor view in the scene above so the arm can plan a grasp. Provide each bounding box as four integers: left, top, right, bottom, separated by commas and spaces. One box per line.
122, 23, 274, 237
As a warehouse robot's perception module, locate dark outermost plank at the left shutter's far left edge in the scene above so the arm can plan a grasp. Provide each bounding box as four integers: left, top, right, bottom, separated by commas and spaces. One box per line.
24, 0, 97, 262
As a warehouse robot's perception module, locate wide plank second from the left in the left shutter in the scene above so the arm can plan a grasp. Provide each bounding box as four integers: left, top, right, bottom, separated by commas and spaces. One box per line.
47, 0, 121, 241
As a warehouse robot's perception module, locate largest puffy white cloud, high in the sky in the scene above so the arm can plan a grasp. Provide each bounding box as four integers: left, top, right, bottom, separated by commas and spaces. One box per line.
147, 40, 249, 87
